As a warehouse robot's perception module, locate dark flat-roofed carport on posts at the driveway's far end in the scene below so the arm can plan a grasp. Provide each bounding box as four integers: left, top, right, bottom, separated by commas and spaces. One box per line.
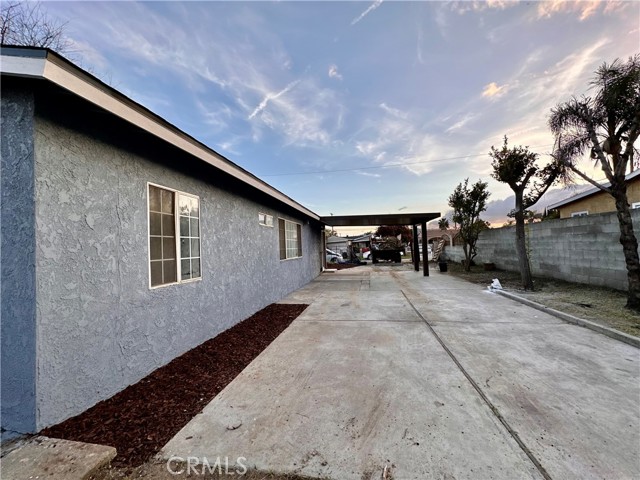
320, 213, 442, 277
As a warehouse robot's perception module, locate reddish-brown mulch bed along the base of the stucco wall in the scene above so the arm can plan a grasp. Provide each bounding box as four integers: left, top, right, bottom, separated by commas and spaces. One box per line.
40, 304, 307, 467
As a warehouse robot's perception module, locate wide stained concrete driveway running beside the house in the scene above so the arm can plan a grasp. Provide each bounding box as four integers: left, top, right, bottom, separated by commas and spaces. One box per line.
160, 266, 640, 480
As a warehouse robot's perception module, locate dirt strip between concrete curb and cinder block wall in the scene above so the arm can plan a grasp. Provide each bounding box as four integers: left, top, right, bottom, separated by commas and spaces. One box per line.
444, 263, 640, 337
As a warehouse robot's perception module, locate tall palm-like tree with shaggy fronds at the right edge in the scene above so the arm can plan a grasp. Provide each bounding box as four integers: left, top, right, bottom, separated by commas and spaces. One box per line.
549, 55, 640, 311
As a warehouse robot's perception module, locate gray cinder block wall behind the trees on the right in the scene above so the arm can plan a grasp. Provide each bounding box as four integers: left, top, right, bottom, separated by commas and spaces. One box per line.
445, 210, 640, 290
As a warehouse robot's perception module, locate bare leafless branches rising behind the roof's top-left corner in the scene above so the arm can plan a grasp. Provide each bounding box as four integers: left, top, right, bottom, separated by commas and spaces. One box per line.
0, 2, 71, 53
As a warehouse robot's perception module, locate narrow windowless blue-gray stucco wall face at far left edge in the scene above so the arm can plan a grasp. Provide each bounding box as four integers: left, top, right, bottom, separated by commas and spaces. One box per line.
0, 87, 36, 437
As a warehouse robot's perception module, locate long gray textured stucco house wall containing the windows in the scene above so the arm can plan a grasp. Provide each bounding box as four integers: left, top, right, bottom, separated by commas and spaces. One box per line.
35, 116, 321, 428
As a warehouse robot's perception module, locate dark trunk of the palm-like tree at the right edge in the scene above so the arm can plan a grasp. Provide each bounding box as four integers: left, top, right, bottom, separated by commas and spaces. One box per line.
611, 182, 640, 312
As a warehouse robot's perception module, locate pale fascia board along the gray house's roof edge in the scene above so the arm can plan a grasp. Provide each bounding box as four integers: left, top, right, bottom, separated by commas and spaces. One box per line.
0, 46, 320, 220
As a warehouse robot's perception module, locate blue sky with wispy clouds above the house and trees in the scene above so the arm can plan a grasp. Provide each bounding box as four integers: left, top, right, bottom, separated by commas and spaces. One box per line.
45, 0, 640, 232
